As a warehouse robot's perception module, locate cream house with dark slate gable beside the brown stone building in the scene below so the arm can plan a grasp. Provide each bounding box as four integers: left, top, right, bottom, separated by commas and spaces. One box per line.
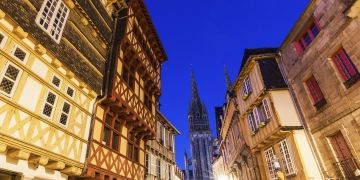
229, 48, 322, 180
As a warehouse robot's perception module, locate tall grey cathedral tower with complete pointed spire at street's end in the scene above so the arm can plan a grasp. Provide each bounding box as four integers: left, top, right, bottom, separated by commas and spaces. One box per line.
185, 74, 213, 180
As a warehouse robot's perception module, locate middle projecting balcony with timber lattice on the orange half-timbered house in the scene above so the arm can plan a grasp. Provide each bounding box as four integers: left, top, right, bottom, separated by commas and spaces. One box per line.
105, 73, 156, 139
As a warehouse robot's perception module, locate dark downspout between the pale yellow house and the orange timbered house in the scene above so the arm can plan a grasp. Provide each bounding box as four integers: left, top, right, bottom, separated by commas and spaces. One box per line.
80, 2, 128, 176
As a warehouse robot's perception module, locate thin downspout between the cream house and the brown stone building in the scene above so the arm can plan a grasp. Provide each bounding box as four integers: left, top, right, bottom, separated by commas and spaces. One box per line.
277, 50, 325, 179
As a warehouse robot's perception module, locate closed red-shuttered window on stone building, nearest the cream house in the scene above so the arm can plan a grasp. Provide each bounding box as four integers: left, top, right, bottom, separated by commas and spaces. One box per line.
305, 76, 326, 109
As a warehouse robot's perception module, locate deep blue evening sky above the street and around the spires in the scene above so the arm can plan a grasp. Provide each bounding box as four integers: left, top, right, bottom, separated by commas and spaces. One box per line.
145, 0, 310, 168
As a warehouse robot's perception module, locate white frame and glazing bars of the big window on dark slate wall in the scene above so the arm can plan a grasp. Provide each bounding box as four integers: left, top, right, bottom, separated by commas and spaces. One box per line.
35, 0, 70, 44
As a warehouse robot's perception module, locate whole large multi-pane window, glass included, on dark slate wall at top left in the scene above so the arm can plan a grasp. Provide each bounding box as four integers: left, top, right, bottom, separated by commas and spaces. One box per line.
36, 0, 70, 43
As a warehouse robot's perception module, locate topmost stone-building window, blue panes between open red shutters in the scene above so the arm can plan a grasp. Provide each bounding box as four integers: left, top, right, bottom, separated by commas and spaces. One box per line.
294, 17, 321, 55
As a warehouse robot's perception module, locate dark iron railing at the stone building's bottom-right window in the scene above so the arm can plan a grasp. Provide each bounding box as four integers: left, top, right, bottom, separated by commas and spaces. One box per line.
334, 158, 359, 180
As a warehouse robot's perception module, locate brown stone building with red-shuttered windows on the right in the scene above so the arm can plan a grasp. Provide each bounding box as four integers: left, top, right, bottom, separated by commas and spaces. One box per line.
279, 0, 360, 179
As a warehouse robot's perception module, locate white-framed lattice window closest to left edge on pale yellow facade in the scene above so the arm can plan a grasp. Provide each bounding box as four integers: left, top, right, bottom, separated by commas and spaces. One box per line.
0, 62, 22, 97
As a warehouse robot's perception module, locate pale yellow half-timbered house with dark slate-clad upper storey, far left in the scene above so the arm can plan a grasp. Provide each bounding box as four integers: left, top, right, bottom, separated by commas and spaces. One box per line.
0, 0, 107, 180
